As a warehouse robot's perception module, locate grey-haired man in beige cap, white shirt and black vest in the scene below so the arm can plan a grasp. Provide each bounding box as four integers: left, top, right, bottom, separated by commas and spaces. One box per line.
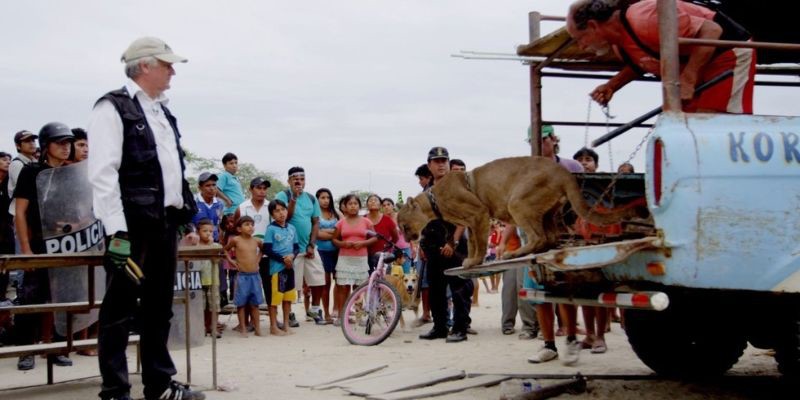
88, 37, 205, 400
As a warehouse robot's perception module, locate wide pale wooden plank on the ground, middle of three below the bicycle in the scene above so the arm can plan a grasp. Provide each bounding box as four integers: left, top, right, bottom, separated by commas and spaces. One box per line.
343, 368, 466, 397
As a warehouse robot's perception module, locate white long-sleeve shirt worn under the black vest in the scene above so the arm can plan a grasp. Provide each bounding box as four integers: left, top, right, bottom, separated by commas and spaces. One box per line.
87, 80, 183, 235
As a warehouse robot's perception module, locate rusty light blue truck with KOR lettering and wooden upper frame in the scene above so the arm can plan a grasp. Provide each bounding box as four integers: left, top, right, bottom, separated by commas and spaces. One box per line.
452, 0, 800, 378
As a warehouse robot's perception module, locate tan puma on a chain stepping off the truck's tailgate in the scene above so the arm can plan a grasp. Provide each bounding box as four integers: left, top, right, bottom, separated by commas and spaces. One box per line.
397, 157, 636, 268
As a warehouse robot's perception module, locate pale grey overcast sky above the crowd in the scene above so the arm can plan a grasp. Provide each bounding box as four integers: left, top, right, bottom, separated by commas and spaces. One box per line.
0, 0, 796, 203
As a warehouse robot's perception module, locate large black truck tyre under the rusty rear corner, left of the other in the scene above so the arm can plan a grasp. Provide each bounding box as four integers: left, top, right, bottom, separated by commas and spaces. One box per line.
625, 305, 747, 378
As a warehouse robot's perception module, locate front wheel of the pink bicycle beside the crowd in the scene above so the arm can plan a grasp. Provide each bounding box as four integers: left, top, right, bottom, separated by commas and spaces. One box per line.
341, 279, 403, 346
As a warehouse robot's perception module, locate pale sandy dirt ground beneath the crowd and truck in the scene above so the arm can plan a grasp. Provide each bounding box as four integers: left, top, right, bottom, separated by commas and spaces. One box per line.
0, 288, 797, 400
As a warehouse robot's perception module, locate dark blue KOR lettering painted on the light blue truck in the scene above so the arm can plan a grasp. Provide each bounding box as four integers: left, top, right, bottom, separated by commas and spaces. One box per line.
728, 132, 800, 163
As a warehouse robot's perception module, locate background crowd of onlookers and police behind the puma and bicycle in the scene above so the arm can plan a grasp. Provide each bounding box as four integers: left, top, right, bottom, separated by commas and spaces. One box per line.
0, 113, 632, 382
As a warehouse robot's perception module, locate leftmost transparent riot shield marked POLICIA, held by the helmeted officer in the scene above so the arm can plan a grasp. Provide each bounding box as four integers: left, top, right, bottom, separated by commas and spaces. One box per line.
36, 162, 106, 335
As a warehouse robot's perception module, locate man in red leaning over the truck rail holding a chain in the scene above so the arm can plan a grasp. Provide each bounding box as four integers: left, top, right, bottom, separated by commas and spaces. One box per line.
567, 0, 756, 114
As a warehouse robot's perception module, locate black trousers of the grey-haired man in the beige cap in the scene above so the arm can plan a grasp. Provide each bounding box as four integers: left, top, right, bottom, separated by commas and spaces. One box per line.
97, 223, 178, 399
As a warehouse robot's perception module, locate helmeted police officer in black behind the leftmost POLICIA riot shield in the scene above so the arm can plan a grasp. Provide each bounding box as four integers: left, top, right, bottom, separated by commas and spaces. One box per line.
14, 122, 75, 371
